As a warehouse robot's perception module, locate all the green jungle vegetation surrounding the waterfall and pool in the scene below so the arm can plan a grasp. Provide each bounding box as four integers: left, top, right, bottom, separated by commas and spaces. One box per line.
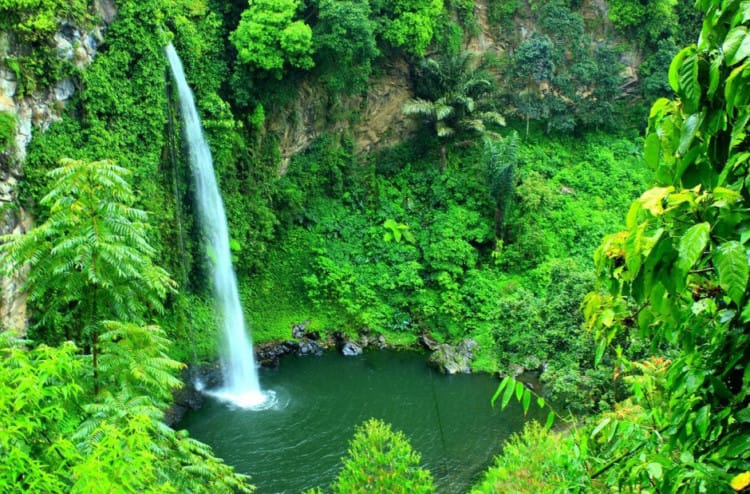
0, 0, 750, 493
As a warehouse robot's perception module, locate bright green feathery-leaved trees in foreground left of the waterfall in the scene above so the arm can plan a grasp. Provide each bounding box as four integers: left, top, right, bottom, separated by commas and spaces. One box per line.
0, 160, 251, 493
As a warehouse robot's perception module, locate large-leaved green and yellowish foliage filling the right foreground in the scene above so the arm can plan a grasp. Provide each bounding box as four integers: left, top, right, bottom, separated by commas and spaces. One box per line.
585, 0, 750, 486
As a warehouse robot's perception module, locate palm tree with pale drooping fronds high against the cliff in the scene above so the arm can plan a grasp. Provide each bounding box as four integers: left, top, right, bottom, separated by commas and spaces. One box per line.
403, 51, 505, 165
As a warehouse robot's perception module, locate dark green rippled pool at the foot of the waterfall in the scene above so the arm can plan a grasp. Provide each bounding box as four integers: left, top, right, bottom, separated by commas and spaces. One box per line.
178, 351, 541, 494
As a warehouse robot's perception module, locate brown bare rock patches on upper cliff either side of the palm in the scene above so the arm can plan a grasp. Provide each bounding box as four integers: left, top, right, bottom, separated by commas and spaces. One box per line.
266, 0, 642, 175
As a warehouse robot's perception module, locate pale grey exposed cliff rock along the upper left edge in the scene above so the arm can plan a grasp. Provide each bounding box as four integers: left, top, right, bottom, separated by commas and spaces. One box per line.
0, 4, 115, 333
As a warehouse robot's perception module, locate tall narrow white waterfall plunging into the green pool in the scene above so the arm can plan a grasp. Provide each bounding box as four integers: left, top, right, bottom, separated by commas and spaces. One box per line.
166, 43, 266, 408
